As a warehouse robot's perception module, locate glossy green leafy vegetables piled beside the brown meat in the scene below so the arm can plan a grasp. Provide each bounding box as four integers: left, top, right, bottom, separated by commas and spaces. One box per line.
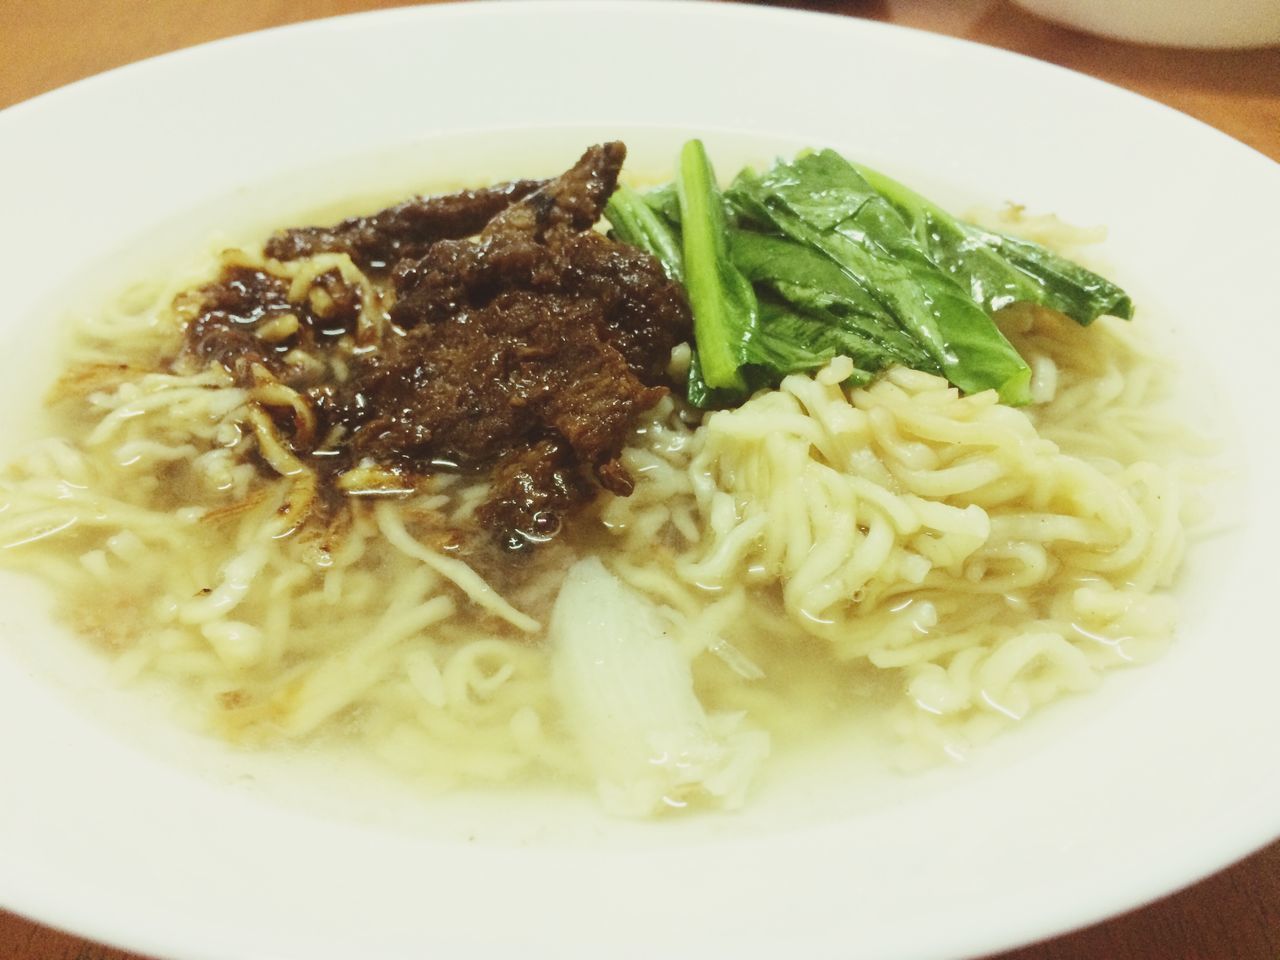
605, 141, 1133, 407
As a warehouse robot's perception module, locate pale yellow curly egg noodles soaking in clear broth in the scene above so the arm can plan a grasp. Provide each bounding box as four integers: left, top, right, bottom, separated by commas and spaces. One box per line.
0, 212, 1184, 814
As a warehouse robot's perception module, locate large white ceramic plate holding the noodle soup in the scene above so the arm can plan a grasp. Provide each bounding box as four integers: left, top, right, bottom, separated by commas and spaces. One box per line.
0, 3, 1280, 960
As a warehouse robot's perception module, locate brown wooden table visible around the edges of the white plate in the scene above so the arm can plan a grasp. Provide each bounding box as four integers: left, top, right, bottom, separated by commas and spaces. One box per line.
0, 0, 1280, 960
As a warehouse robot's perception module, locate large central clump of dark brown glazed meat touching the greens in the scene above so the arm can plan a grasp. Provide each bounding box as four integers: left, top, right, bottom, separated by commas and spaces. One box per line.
335, 143, 690, 543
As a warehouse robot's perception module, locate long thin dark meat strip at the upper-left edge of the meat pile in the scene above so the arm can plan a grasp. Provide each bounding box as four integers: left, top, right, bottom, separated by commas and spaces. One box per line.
265, 180, 544, 273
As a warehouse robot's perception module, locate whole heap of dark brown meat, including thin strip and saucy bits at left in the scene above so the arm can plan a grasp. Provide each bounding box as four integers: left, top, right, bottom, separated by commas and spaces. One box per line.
187, 143, 690, 549
